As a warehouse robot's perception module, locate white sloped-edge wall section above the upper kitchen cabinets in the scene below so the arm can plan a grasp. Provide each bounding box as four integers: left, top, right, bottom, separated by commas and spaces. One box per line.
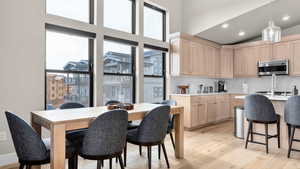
182, 0, 274, 35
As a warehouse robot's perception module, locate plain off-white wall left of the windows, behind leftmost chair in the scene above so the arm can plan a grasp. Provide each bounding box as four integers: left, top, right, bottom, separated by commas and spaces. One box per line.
0, 0, 45, 158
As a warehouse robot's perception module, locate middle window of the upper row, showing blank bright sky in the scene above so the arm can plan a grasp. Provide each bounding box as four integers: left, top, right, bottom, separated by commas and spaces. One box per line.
104, 0, 135, 33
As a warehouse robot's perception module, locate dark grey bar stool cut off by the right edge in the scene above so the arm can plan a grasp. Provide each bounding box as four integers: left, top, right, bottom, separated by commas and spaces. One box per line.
284, 96, 300, 158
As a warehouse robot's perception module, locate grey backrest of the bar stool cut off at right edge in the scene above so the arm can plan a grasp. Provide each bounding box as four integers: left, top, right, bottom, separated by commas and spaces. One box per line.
284, 96, 300, 126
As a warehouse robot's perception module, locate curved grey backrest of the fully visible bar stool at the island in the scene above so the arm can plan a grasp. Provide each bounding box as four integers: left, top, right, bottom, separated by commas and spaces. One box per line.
244, 94, 277, 122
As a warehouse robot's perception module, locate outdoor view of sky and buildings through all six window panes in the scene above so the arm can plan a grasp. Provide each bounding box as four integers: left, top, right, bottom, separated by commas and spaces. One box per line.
46, 0, 165, 109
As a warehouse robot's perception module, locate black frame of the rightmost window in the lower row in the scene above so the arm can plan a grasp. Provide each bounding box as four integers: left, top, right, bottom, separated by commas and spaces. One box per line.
144, 44, 168, 100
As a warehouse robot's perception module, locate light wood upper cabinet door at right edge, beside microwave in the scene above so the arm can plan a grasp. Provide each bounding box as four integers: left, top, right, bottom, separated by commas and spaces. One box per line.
290, 41, 300, 76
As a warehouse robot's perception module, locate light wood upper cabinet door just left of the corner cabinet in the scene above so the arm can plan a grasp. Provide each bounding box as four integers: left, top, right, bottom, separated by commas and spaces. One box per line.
204, 46, 216, 77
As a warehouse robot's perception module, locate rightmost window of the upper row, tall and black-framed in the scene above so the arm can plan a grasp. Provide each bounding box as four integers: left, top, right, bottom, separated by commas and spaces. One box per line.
144, 3, 166, 41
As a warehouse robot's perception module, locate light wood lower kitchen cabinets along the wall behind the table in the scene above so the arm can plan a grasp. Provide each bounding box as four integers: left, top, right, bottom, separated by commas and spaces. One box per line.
171, 94, 231, 130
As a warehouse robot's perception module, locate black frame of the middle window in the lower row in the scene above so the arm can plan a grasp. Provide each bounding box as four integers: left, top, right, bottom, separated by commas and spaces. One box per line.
102, 35, 138, 103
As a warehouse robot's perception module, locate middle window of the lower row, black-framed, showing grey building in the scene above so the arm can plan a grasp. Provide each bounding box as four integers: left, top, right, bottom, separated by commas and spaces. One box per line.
103, 37, 136, 104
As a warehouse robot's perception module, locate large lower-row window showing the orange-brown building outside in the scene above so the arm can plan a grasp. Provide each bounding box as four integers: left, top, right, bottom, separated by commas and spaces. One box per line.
46, 26, 94, 109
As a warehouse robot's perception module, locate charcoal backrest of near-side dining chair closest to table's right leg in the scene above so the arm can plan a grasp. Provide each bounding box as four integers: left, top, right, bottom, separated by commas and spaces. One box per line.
138, 106, 170, 144
